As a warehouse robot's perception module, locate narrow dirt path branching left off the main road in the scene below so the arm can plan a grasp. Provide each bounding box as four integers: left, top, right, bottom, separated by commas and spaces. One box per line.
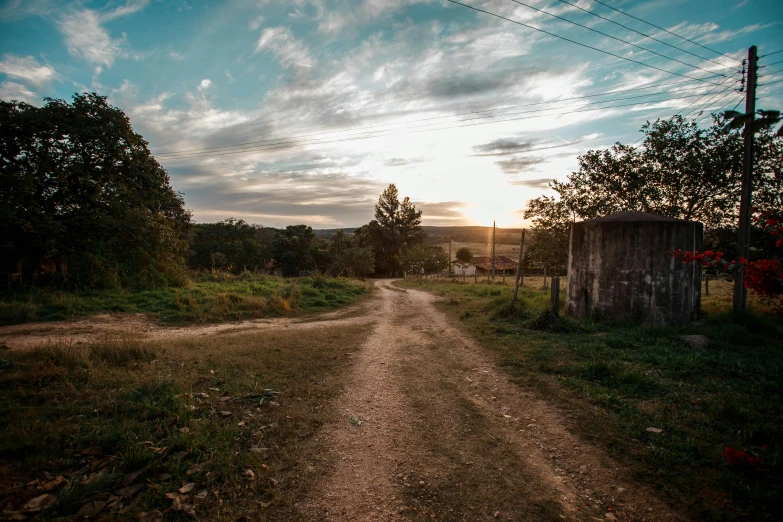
0, 305, 372, 349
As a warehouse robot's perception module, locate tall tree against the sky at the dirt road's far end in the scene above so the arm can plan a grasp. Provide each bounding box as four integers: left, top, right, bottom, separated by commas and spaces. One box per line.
353, 184, 425, 276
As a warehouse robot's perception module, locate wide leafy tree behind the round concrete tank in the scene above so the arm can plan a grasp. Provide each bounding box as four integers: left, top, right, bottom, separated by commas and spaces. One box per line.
525, 116, 783, 258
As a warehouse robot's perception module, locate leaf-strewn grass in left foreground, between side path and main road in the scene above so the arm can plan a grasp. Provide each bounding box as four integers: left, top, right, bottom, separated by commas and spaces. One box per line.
0, 326, 369, 521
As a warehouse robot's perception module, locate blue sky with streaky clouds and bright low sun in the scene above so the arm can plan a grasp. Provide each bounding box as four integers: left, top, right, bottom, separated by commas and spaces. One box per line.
0, 0, 783, 228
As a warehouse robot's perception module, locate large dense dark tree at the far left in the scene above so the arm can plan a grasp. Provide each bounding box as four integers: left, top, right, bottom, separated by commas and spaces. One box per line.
0, 93, 190, 286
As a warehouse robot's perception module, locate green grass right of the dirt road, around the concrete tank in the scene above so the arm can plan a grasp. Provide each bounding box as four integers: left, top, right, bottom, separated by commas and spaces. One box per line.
400, 280, 783, 520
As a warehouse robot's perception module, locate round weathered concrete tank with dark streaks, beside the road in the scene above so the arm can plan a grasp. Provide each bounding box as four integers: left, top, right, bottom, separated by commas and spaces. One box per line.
566, 212, 703, 324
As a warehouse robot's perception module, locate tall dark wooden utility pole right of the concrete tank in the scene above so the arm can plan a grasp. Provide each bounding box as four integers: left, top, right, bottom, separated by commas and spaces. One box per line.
734, 45, 757, 315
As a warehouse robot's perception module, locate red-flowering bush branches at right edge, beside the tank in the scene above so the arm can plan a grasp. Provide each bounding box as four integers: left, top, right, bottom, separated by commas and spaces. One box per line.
669, 217, 783, 306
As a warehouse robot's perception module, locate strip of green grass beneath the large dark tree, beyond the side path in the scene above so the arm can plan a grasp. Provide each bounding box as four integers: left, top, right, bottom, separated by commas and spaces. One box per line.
0, 273, 367, 325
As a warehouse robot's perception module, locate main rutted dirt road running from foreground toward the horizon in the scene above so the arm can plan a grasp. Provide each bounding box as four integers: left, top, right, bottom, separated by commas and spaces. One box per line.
305, 281, 682, 521
